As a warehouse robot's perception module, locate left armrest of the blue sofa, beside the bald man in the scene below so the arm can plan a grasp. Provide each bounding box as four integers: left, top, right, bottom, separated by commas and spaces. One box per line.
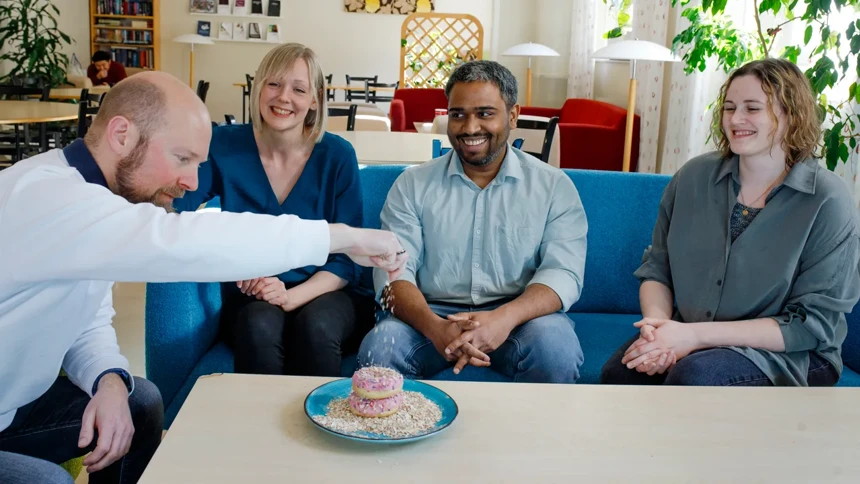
144, 282, 221, 414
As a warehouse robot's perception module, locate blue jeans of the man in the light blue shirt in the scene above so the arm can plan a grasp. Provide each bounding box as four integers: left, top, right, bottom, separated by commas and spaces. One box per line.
358, 304, 583, 383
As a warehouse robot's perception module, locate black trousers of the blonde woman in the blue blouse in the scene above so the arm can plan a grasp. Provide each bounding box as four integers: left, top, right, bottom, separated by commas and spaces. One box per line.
222, 290, 376, 376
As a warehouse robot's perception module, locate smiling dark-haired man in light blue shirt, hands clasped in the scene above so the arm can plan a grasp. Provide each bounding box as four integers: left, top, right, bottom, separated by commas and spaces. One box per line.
359, 61, 588, 383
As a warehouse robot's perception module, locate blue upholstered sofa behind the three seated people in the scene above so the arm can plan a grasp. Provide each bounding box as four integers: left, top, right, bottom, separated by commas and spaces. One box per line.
146, 166, 860, 425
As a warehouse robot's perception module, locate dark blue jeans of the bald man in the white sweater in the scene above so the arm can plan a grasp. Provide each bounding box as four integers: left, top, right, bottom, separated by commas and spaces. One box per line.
0, 377, 164, 484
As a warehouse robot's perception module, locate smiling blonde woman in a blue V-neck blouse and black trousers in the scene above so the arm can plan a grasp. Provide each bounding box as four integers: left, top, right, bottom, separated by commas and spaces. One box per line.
174, 43, 375, 376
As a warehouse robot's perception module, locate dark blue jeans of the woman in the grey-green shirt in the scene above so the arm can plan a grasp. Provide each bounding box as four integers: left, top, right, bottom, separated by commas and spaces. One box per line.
600, 334, 839, 387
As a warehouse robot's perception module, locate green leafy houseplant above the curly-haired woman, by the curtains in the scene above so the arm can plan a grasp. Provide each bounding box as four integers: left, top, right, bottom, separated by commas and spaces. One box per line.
672, 0, 860, 170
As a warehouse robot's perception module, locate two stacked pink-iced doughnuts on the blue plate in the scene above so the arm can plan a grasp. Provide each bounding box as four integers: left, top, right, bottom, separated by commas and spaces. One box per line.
348, 366, 403, 417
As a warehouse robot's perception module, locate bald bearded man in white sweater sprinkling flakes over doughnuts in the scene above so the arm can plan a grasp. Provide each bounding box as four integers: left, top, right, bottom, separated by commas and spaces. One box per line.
0, 72, 406, 484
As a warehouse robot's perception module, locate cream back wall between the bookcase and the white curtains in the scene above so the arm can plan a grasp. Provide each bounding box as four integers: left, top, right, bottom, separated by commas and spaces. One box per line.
161, 0, 490, 121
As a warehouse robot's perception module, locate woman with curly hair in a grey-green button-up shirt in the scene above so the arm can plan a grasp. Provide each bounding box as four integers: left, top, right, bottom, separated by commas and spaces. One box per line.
601, 59, 860, 386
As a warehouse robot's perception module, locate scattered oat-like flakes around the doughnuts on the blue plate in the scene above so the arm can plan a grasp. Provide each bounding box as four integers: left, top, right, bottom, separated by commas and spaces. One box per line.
314, 392, 442, 438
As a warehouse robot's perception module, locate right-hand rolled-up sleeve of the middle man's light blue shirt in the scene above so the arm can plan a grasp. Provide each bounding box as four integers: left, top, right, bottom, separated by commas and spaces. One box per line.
529, 174, 588, 311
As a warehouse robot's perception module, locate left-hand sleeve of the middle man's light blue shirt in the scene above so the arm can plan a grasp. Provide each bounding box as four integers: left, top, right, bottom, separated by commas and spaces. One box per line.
373, 170, 424, 299
